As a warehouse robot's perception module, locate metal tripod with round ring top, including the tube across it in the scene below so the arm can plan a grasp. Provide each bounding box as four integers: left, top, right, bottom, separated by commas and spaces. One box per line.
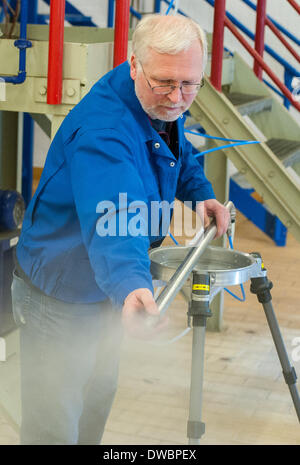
150, 201, 300, 444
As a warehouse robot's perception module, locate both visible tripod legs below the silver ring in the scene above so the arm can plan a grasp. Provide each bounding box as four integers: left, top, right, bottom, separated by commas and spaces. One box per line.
187, 253, 300, 444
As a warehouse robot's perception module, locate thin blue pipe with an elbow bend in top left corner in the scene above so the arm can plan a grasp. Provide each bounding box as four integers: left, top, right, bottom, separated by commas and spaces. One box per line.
0, 0, 32, 84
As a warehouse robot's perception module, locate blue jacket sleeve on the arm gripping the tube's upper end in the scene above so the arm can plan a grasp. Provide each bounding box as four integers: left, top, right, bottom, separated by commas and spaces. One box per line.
176, 133, 215, 210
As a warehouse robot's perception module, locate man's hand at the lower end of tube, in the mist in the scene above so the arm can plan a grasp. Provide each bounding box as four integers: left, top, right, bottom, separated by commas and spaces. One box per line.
122, 288, 168, 339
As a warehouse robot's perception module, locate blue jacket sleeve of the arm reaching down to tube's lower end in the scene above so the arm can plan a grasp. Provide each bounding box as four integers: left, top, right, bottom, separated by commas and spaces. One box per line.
70, 129, 153, 306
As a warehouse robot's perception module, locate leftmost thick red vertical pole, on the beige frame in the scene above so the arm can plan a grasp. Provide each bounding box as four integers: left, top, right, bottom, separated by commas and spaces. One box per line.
47, 0, 65, 105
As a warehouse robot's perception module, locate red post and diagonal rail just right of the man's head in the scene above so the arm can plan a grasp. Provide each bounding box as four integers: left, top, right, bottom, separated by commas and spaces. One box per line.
210, 0, 300, 111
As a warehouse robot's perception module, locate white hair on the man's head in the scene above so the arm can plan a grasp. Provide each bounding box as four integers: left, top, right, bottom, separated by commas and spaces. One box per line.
132, 14, 207, 71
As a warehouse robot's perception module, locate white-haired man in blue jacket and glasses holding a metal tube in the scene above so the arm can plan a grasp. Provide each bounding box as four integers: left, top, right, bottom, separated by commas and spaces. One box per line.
12, 15, 229, 444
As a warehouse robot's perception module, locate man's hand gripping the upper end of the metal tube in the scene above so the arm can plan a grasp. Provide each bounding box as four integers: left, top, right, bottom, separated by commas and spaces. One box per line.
196, 199, 230, 239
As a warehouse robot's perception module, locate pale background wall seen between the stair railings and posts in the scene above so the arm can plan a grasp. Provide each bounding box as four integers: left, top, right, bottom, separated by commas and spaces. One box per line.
34, 0, 299, 166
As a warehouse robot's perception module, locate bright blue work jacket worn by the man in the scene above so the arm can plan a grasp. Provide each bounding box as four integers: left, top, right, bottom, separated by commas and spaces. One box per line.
16, 63, 214, 306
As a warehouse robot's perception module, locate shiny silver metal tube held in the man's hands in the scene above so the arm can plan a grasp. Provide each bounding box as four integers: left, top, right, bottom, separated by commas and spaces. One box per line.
156, 201, 234, 314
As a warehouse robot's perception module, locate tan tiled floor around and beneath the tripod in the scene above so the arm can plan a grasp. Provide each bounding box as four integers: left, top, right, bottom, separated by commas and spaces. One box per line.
0, 209, 300, 445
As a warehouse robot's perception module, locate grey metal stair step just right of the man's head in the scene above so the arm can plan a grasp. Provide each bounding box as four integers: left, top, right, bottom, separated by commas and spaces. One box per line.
224, 92, 272, 115
